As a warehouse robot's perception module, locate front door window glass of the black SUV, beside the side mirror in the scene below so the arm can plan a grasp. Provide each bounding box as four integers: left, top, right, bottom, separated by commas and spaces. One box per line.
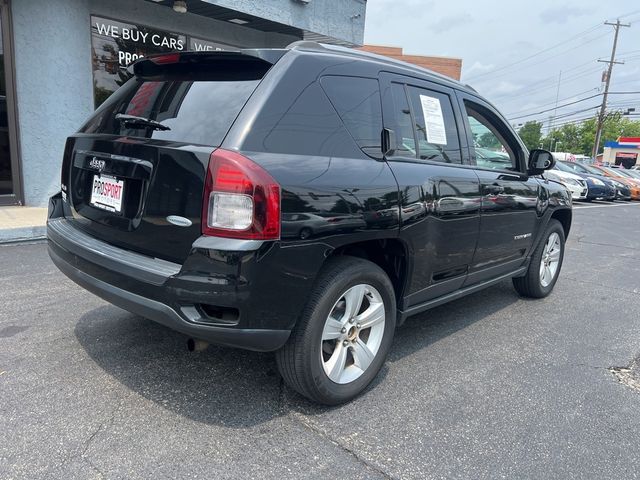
465, 101, 519, 171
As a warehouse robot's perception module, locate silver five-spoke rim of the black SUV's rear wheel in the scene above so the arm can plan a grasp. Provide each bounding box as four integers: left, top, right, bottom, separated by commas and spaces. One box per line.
320, 284, 385, 384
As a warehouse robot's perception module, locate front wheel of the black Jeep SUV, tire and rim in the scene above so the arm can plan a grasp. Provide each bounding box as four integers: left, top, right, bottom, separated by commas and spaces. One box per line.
513, 219, 565, 298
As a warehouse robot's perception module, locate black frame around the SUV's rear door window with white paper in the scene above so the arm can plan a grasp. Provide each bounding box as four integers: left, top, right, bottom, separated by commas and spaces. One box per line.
380, 72, 469, 167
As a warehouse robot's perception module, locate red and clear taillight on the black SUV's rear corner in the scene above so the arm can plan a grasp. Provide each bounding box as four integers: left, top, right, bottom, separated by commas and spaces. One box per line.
202, 148, 280, 240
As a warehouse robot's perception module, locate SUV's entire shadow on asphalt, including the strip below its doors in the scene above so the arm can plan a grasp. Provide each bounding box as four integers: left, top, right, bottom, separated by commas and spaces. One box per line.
75, 282, 519, 420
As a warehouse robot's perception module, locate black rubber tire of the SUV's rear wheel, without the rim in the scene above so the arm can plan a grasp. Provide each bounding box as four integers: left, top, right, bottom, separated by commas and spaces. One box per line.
276, 256, 396, 405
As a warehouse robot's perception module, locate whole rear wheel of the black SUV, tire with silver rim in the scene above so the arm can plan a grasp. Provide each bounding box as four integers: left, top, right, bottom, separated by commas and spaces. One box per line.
276, 257, 396, 405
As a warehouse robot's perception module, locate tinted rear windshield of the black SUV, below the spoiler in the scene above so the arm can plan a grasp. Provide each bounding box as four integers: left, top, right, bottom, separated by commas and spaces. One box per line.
80, 75, 260, 146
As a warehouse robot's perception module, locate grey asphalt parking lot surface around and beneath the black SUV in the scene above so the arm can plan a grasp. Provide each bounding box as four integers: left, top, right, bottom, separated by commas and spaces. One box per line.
0, 202, 640, 479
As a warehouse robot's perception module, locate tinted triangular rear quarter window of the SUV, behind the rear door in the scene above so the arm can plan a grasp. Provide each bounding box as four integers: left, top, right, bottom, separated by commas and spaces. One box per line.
320, 76, 382, 158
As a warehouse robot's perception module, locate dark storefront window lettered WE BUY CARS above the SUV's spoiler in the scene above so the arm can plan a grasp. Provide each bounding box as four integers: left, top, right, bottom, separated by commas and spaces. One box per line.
91, 16, 237, 108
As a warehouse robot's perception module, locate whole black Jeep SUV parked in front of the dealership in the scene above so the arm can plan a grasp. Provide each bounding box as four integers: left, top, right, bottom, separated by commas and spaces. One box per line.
48, 42, 571, 404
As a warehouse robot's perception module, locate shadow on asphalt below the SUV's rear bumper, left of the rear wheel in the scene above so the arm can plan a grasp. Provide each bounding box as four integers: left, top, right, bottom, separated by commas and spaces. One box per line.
75, 305, 282, 428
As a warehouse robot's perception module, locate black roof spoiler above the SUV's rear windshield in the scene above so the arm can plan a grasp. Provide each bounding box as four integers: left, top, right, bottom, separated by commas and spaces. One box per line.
127, 48, 288, 80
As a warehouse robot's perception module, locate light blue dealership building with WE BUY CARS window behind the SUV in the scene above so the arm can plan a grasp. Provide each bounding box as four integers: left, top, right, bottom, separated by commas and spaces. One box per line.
0, 0, 366, 207
